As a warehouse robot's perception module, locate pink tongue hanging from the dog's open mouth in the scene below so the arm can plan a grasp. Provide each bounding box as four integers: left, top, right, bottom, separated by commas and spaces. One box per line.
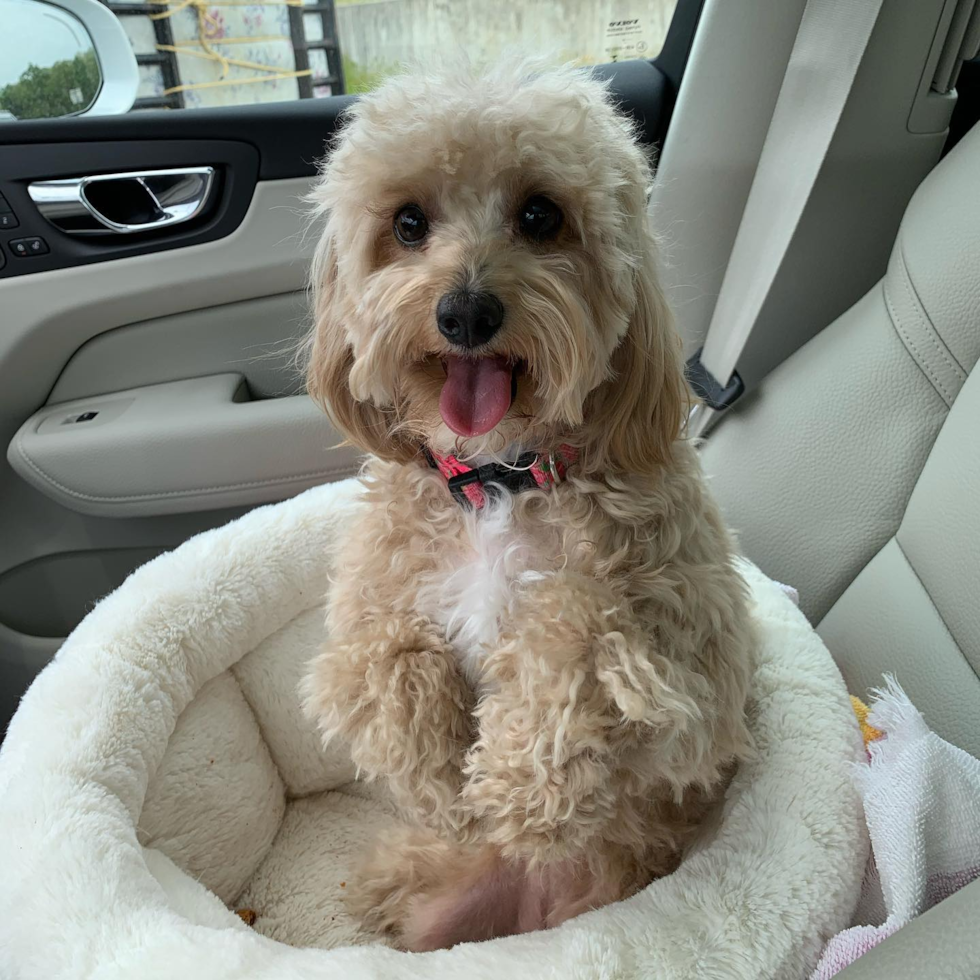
439, 354, 513, 436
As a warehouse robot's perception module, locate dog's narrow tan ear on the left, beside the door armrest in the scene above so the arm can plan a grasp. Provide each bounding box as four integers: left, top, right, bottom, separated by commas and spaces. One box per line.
306, 228, 416, 461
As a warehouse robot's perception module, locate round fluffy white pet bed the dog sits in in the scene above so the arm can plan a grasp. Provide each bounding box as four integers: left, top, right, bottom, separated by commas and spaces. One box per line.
0, 483, 865, 980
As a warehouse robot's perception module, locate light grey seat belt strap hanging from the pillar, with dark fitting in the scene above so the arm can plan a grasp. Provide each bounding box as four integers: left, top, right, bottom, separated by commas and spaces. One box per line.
688, 0, 882, 436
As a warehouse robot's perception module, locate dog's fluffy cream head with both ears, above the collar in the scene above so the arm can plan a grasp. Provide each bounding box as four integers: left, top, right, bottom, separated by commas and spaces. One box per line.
309, 63, 684, 469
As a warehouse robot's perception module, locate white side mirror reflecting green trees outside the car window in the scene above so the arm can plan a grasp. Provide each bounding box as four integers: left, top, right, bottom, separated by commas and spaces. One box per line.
0, 0, 139, 122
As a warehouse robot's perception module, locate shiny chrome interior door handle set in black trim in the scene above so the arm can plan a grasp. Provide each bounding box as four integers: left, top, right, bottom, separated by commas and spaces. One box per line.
27, 167, 214, 235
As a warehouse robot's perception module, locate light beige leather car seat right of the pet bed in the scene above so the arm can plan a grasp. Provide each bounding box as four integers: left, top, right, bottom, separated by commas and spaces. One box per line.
703, 126, 980, 980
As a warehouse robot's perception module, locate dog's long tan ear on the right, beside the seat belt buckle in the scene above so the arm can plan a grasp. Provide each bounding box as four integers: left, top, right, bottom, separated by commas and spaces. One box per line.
585, 241, 691, 473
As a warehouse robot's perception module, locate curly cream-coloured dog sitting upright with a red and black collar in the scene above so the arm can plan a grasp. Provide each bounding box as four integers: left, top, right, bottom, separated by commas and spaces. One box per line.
303, 64, 754, 950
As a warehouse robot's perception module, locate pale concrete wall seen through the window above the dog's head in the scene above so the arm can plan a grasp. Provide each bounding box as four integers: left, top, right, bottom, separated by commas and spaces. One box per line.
337, 0, 676, 81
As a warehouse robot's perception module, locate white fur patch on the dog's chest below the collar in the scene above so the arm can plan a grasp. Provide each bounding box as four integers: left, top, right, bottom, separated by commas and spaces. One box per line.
418, 494, 534, 690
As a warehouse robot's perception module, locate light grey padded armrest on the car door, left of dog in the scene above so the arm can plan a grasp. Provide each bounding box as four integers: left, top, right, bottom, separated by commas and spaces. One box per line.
7, 374, 356, 517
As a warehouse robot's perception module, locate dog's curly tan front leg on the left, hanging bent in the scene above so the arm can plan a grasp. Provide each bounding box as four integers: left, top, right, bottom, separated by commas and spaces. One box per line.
303, 619, 472, 833
